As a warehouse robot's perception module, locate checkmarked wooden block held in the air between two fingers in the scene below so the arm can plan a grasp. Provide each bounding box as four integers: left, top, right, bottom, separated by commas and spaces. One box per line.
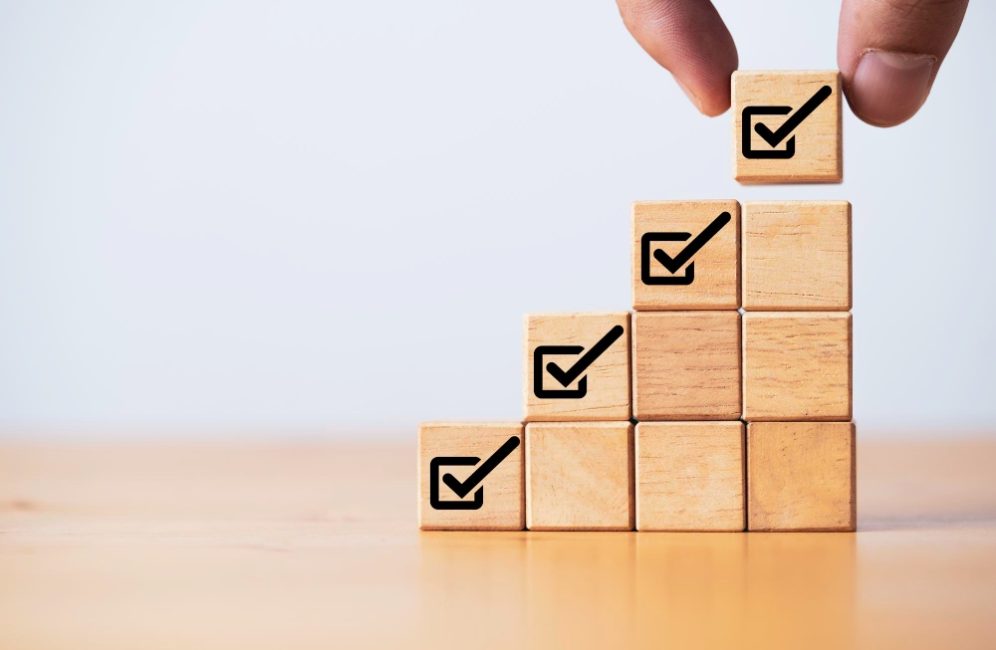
732, 70, 844, 183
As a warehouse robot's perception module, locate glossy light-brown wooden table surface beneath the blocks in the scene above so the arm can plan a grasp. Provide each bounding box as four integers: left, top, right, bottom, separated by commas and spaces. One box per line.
0, 434, 996, 650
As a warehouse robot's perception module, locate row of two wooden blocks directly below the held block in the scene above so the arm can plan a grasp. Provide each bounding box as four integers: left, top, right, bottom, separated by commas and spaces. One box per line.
632, 200, 851, 311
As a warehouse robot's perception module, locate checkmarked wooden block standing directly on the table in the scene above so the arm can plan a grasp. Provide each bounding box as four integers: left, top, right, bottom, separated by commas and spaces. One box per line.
418, 422, 525, 530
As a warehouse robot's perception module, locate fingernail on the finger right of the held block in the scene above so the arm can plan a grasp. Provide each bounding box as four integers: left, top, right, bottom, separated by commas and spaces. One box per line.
849, 50, 937, 126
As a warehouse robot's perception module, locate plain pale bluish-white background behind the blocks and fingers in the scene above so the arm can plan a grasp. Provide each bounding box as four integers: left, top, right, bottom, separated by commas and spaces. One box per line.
0, 0, 996, 439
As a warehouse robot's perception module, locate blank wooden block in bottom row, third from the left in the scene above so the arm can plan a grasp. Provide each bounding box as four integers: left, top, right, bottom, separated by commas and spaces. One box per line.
636, 422, 746, 531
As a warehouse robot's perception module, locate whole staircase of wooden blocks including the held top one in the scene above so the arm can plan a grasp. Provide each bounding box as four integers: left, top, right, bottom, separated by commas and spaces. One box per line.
419, 72, 855, 531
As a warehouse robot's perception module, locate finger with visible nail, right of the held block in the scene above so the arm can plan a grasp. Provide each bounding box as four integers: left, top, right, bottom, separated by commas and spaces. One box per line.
837, 0, 968, 126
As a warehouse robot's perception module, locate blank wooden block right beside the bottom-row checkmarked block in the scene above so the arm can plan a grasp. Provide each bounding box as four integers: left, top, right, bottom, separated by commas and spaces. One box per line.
526, 422, 633, 530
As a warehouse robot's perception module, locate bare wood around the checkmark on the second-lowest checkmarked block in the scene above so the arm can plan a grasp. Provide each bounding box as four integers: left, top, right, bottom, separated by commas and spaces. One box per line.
523, 312, 632, 422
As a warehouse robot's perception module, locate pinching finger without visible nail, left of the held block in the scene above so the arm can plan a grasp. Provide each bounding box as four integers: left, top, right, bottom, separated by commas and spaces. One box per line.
616, 0, 737, 115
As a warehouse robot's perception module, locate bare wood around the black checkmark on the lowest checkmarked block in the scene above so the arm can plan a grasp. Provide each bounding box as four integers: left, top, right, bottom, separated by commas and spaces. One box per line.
418, 422, 526, 530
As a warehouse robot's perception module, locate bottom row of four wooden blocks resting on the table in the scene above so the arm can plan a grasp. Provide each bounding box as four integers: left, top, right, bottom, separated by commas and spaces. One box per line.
419, 421, 856, 531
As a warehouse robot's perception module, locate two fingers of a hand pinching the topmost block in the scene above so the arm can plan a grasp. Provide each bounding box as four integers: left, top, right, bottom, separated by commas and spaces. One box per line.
617, 0, 968, 126
